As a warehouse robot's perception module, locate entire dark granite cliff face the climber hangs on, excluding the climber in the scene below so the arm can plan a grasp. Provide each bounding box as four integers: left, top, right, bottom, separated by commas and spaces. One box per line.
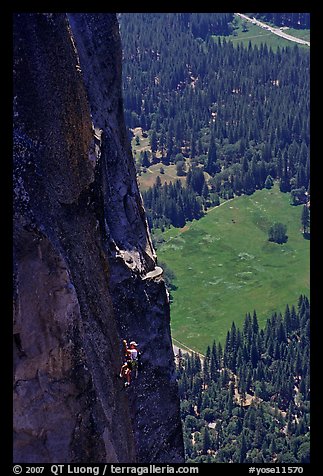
13, 13, 183, 463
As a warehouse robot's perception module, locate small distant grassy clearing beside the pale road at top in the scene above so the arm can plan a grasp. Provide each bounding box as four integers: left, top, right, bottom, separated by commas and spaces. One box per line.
214, 17, 309, 51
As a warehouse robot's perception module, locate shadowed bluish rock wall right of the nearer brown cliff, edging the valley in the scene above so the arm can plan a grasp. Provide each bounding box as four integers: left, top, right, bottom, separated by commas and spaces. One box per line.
69, 14, 183, 462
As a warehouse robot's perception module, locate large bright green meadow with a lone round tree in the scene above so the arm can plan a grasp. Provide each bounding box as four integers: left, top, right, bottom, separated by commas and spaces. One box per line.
158, 182, 310, 353
